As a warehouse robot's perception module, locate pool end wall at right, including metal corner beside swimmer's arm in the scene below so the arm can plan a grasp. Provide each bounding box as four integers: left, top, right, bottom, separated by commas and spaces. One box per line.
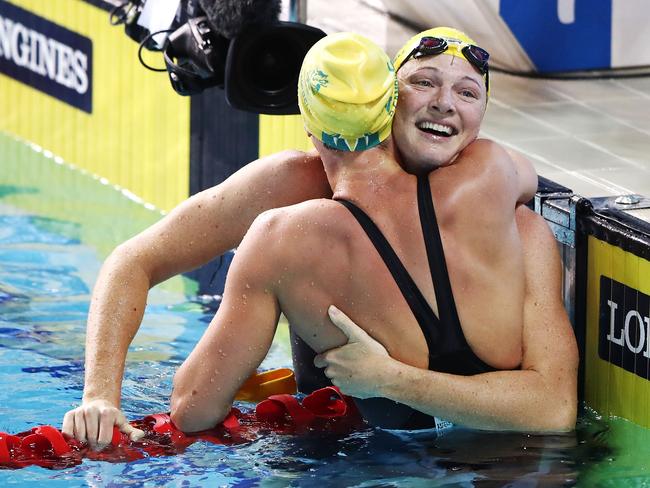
533, 182, 650, 427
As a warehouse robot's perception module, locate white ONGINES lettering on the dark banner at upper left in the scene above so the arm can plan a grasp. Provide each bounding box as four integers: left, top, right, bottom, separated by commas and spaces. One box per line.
0, 13, 89, 95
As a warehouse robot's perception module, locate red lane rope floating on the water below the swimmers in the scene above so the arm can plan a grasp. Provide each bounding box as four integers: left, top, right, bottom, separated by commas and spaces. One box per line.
0, 387, 363, 469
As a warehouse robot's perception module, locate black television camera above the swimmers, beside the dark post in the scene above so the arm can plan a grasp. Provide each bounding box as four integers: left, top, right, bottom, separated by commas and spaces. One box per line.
110, 0, 325, 115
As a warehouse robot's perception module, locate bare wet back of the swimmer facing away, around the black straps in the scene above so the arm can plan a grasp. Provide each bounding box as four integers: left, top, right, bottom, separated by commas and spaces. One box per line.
253, 147, 523, 368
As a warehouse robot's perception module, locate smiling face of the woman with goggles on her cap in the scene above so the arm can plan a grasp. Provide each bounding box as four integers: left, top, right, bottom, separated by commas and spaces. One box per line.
393, 54, 487, 173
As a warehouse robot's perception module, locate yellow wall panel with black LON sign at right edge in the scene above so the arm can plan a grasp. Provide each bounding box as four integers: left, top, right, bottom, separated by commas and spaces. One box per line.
581, 199, 650, 427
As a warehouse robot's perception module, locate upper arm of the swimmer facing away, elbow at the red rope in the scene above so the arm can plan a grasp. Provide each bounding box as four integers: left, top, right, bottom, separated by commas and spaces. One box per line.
171, 212, 280, 432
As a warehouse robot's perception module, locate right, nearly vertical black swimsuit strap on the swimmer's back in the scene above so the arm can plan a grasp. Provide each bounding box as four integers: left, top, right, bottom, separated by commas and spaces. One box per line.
418, 175, 462, 336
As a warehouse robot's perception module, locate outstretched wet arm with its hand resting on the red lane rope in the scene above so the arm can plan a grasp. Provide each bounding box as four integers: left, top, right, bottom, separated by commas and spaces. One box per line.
64, 151, 331, 444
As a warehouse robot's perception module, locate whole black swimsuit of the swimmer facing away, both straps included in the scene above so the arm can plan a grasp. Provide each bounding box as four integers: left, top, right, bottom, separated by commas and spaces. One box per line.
292, 175, 494, 429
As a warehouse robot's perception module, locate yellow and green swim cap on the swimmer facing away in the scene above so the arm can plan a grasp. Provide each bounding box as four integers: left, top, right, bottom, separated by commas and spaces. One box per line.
298, 32, 397, 151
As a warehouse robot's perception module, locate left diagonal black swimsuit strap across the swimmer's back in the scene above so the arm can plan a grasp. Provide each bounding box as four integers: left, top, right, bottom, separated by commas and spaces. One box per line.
336, 195, 439, 362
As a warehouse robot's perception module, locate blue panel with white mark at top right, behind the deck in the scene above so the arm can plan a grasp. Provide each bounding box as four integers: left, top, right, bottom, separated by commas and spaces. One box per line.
499, 0, 612, 72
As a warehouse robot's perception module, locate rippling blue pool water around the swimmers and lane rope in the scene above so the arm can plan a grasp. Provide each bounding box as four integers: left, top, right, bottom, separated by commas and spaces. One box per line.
0, 135, 650, 487
